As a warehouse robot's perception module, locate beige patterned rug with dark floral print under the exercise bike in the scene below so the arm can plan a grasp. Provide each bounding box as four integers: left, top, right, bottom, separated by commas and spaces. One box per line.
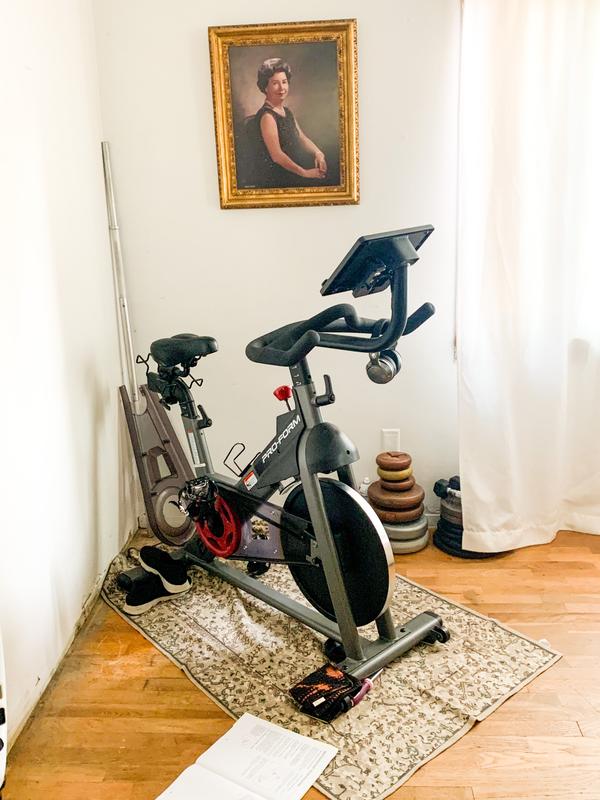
102, 551, 560, 800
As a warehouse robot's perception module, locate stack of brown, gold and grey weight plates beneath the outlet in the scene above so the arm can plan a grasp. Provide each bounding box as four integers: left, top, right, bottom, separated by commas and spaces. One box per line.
368, 451, 429, 553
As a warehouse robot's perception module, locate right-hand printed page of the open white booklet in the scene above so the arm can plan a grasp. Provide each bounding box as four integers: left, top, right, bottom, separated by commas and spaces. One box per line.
196, 714, 337, 800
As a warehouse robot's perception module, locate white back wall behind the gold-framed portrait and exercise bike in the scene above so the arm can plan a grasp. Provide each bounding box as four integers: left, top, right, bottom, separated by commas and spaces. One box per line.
95, 0, 459, 507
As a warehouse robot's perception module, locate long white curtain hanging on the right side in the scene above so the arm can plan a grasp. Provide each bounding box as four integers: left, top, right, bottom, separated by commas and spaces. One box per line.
457, 0, 600, 552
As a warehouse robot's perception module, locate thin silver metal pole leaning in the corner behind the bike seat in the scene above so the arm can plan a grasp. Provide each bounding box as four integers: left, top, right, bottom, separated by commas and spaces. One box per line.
102, 142, 140, 410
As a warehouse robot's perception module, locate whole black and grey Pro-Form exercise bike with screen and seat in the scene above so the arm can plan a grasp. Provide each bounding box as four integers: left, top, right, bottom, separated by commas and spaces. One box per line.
137, 226, 449, 678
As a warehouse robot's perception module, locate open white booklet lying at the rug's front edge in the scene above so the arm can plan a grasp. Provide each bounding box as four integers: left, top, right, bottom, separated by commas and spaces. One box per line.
157, 714, 337, 800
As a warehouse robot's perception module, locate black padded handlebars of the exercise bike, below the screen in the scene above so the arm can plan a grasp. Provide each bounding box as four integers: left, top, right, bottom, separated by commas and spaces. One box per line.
246, 266, 435, 367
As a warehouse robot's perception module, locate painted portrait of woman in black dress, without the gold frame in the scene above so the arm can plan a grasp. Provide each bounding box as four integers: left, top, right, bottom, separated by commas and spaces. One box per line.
229, 42, 340, 189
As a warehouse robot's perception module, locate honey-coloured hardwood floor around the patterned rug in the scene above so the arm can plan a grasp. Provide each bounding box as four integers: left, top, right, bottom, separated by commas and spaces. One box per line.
4, 533, 600, 800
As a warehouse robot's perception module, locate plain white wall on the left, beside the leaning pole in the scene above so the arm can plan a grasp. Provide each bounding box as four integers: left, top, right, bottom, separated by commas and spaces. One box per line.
0, 0, 128, 734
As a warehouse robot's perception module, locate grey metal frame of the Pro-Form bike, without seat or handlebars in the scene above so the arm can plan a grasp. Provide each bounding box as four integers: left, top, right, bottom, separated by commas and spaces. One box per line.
170, 359, 441, 678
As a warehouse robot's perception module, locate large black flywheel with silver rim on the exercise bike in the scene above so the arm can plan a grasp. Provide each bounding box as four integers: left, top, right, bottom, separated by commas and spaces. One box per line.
281, 478, 395, 626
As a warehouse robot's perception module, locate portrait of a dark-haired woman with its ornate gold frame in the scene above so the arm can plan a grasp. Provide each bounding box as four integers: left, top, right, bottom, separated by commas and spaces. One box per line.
209, 19, 359, 208
